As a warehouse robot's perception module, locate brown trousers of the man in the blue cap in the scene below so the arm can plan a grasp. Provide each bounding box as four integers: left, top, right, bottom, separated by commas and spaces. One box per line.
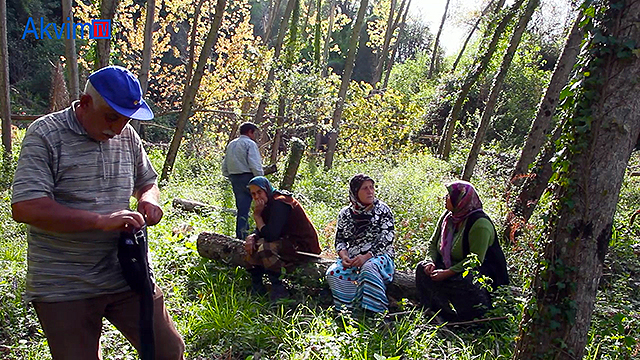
33, 287, 184, 360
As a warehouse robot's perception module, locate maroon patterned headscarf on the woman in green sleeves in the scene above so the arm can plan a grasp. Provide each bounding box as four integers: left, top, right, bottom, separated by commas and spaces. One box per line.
440, 180, 482, 268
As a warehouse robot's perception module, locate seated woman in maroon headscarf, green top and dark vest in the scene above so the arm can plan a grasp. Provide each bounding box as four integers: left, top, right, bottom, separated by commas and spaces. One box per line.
416, 181, 509, 322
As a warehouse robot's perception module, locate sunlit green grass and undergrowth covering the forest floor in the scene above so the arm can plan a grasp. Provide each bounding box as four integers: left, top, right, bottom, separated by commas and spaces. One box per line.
0, 131, 640, 360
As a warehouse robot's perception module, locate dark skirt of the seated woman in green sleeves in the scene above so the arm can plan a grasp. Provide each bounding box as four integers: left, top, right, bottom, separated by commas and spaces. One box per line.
416, 263, 491, 322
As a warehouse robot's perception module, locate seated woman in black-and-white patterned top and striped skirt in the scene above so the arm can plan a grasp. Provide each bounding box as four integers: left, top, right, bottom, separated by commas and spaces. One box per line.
326, 174, 395, 313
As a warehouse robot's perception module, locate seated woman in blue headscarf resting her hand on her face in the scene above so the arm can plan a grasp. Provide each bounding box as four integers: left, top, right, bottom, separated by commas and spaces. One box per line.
244, 176, 321, 301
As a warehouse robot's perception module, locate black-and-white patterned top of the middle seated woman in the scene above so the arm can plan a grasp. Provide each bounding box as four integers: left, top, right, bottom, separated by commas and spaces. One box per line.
335, 200, 395, 258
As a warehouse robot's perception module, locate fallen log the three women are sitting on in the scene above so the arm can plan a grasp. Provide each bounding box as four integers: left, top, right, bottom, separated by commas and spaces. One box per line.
197, 232, 417, 302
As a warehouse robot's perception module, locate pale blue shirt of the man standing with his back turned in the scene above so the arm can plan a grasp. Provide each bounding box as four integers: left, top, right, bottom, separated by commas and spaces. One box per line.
222, 135, 264, 177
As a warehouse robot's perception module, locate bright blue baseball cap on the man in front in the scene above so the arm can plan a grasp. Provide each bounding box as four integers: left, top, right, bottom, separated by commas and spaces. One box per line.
89, 66, 153, 120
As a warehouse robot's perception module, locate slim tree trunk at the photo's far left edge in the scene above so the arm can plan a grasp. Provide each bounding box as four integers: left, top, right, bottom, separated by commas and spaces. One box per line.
0, 0, 11, 154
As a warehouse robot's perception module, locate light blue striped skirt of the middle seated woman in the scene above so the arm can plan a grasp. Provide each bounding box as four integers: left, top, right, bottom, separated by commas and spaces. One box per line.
326, 255, 395, 312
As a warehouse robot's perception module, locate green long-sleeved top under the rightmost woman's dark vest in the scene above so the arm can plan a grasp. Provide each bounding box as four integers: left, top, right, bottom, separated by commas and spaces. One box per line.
427, 212, 495, 273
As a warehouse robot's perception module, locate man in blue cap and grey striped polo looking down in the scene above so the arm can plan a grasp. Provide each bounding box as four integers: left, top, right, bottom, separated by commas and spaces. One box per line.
12, 66, 184, 359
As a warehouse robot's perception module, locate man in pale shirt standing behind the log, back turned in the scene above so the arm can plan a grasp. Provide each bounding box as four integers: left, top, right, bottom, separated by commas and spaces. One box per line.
222, 122, 264, 240
